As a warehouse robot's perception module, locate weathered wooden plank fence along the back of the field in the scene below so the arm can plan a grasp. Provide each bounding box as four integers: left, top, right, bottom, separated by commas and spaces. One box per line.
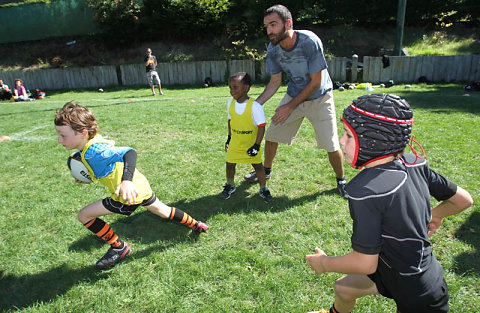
0, 55, 480, 89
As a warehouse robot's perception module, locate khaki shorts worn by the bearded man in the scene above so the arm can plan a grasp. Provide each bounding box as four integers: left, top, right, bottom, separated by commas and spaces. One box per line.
265, 92, 340, 152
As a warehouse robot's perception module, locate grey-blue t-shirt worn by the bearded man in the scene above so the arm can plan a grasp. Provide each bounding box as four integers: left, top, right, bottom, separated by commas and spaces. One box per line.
267, 30, 333, 100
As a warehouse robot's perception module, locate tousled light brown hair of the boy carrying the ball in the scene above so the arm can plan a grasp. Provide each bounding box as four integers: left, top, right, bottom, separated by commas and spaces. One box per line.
55, 102, 98, 139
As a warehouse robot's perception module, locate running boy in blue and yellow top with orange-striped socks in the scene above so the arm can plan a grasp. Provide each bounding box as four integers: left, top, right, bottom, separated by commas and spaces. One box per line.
55, 102, 208, 269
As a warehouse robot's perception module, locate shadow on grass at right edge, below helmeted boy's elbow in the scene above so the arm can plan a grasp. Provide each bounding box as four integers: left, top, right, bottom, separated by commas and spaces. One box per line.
453, 211, 480, 275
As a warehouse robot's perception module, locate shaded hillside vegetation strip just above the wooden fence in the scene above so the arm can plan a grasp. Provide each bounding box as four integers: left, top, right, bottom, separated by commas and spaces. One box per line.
0, 26, 480, 70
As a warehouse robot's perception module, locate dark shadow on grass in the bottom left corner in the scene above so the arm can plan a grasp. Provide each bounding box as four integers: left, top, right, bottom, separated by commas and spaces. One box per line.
0, 264, 108, 312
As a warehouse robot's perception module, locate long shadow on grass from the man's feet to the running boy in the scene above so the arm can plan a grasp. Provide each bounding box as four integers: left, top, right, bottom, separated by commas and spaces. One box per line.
69, 178, 340, 251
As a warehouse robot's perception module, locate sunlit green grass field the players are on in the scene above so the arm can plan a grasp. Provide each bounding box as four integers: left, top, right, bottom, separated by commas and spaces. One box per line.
0, 84, 480, 312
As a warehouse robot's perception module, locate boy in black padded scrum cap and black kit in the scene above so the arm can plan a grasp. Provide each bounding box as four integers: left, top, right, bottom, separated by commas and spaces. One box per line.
306, 94, 473, 313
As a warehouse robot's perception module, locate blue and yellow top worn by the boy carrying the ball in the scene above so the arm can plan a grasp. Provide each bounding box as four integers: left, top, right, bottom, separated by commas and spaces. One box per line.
81, 135, 153, 204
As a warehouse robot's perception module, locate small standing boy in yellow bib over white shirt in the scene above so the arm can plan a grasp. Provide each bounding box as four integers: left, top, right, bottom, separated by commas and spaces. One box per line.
220, 72, 273, 202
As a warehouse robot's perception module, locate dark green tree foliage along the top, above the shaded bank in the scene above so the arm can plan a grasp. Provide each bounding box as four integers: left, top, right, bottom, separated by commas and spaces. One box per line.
87, 0, 480, 42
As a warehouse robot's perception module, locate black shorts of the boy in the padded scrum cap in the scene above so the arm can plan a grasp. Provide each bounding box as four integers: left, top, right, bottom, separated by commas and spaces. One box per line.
368, 260, 449, 313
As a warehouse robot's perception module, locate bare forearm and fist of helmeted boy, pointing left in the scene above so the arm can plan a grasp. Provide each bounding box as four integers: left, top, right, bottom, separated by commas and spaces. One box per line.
305, 248, 378, 275
